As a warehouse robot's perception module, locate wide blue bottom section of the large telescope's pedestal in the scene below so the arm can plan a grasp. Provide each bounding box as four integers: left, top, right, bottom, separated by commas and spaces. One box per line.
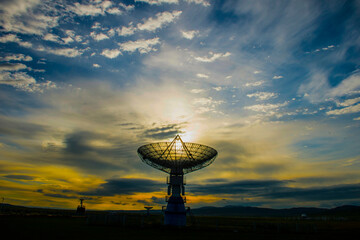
164, 196, 186, 227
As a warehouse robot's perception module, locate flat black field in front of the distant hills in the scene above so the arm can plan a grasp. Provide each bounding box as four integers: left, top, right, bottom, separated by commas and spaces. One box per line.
0, 214, 360, 240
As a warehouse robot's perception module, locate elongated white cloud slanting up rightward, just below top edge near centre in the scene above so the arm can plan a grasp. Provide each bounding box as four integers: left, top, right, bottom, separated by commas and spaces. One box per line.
137, 11, 182, 32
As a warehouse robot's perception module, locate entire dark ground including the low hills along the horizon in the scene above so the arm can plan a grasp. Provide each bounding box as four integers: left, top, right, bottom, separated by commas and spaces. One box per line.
0, 205, 360, 240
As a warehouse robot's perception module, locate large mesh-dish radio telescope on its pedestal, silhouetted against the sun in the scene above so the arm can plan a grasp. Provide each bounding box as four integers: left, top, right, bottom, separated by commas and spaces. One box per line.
137, 135, 217, 226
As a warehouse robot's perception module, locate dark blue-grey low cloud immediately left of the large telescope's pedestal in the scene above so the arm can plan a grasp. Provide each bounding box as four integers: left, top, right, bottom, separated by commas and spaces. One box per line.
80, 178, 164, 196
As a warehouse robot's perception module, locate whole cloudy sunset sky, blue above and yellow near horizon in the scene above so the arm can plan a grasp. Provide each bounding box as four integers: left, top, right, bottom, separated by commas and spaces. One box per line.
0, 0, 360, 210
